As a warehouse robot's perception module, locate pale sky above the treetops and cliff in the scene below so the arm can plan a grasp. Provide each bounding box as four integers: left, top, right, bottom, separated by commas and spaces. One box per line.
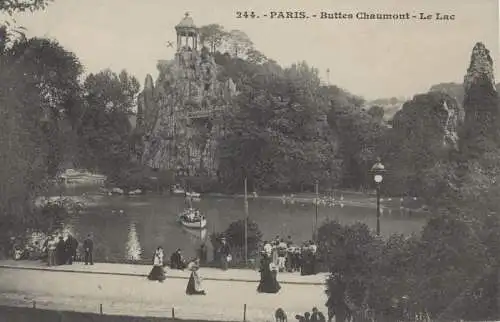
4, 0, 500, 99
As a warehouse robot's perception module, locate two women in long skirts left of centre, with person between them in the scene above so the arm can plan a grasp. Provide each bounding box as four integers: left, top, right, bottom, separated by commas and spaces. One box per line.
148, 246, 206, 295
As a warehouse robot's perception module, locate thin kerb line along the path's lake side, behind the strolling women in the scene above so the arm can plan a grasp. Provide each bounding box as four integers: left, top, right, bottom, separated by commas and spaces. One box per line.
0, 264, 326, 286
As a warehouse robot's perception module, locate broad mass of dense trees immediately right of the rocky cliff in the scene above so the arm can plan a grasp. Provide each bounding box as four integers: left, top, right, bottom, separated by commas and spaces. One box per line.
216, 55, 383, 191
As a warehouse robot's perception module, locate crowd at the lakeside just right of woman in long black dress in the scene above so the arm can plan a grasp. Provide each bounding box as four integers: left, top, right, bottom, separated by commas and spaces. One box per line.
261, 236, 317, 275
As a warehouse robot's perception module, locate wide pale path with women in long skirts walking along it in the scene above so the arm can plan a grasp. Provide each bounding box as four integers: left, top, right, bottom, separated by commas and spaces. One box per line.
0, 261, 326, 321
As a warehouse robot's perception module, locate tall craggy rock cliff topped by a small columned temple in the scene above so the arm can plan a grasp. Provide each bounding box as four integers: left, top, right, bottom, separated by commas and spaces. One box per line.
136, 14, 236, 176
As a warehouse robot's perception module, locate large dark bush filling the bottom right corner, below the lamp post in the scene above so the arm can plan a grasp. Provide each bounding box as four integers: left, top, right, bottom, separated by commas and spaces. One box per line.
318, 214, 500, 321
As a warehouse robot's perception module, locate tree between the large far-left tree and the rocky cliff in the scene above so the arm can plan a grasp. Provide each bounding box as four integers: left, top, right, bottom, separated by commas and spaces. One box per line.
78, 70, 139, 179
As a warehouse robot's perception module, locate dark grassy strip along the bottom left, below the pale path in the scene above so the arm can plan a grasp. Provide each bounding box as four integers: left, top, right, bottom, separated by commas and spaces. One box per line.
0, 306, 234, 322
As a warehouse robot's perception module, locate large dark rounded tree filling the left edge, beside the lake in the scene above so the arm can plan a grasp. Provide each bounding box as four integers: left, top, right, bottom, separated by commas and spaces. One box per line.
0, 38, 82, 242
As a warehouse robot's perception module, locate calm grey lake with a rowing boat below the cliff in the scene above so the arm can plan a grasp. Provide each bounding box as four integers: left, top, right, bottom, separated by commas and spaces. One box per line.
56, 187, 425, 262
